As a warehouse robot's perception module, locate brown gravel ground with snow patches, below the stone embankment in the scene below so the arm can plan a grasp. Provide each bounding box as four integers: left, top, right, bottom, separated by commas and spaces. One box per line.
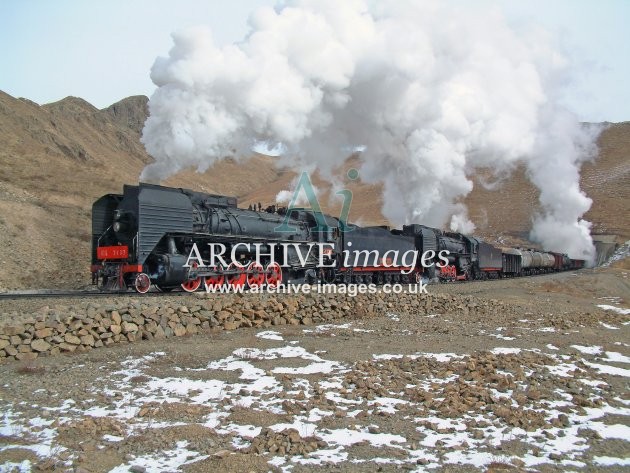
0, 269, 630, 472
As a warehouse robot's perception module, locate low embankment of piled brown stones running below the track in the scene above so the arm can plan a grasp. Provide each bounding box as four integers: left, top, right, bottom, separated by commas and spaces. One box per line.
0, 292, 509, 360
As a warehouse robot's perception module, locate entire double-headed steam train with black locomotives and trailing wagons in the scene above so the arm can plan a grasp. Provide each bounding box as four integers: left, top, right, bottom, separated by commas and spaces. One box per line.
91, 183, 584, 293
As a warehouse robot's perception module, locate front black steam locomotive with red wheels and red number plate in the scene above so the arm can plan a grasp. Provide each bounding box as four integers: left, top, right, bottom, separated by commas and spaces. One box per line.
92, 183, 333, 293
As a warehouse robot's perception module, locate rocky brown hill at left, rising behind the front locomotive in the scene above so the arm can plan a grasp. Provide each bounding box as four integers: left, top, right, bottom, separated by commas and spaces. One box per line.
0, 92, 277, 290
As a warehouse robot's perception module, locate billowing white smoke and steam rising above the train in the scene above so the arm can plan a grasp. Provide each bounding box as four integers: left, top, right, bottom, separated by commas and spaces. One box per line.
141, 0, 595, 257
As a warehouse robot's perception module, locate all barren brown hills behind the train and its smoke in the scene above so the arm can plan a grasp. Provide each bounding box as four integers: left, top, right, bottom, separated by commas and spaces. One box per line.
0, 87, 630, 290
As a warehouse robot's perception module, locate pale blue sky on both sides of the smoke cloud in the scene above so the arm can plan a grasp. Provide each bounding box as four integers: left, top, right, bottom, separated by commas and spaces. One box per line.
0, 0, 630, 121
